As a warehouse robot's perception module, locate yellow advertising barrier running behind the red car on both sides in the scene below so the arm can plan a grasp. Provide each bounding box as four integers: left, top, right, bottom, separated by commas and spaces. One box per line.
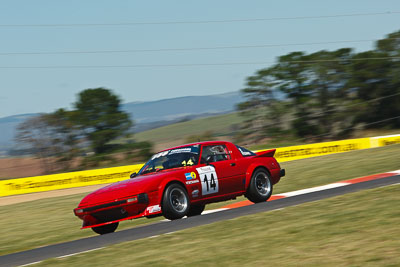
0, 134, 400, 197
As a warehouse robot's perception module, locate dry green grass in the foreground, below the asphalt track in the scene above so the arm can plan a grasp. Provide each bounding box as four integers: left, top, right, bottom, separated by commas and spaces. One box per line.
38, 185, 400, 266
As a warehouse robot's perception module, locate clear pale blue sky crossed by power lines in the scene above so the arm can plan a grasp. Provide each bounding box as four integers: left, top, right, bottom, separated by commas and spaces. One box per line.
0, 0, 400, 117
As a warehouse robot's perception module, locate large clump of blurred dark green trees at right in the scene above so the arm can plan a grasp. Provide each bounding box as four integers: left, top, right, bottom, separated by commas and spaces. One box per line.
238, 31, 400, 142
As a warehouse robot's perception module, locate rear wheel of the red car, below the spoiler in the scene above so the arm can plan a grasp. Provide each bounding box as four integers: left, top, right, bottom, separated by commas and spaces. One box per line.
246, 168, 272, 203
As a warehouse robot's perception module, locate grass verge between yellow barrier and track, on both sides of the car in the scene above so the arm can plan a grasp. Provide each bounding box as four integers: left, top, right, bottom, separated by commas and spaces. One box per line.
0, 144, 400, 255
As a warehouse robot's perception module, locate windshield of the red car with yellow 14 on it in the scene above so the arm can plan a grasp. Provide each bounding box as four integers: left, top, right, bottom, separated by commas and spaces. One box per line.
138, 145, 200, 175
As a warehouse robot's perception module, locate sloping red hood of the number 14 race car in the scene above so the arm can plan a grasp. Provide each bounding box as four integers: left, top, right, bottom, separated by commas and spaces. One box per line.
79, 171, 178, 208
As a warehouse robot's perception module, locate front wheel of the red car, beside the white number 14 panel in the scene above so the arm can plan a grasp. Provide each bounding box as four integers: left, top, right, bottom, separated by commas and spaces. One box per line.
161, 184, 190, 220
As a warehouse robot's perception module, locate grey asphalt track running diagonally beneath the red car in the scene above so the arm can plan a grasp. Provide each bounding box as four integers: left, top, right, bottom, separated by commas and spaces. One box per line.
0, 175, 400, 266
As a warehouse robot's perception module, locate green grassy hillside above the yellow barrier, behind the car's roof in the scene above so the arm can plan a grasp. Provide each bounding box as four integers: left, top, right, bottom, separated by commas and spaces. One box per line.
134, 113, 243, 143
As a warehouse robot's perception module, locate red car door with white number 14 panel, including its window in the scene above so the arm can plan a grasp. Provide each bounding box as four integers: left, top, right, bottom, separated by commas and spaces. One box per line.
196, 144, 243, 197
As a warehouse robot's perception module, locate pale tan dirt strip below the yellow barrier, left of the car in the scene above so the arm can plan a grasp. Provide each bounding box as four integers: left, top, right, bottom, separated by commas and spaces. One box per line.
0, 184, 107, 206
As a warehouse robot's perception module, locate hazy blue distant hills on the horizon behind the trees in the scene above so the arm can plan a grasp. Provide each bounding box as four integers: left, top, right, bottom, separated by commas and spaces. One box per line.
0, 92, 243, 153
